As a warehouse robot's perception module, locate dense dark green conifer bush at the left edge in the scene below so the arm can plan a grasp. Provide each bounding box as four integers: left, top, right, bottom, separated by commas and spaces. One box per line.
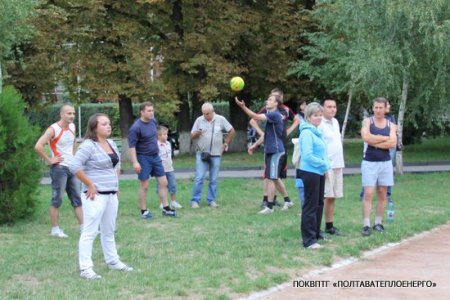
0, 87, 41, 224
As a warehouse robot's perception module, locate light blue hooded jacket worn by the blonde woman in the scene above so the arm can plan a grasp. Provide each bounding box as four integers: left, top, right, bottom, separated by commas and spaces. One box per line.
299, 122, 331, 175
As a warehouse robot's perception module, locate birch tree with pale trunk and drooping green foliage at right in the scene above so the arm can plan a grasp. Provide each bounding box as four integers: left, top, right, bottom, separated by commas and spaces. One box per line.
293, 0, 450, 169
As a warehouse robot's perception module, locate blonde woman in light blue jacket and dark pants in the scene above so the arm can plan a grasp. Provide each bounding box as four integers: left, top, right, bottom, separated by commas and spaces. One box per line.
296, 102, 330, 249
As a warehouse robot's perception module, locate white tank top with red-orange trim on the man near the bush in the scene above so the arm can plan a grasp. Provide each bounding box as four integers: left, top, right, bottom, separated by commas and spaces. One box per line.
50, 123, 75, 167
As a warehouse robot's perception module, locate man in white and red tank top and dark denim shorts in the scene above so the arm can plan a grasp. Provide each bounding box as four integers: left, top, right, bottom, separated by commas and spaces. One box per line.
34, 104, 83, 238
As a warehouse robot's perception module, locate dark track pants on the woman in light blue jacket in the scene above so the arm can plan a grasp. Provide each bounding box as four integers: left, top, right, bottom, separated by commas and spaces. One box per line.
299, 170, 325, 247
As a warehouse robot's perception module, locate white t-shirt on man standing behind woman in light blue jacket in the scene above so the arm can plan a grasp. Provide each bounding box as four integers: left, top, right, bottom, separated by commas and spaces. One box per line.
319, 117, 345, 169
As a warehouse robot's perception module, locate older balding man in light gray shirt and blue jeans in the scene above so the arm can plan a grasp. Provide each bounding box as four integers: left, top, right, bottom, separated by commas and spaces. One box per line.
191, 102, 234, 208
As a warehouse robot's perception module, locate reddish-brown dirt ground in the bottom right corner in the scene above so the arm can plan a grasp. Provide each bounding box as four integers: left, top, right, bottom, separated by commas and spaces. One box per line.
248, 223, 450, 300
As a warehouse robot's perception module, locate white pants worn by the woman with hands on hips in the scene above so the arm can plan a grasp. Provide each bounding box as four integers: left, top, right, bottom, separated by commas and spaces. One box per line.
78, 193, 119, 270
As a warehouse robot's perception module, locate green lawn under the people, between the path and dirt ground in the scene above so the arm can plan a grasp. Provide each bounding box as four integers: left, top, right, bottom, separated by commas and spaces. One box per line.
0, 173, 450, 299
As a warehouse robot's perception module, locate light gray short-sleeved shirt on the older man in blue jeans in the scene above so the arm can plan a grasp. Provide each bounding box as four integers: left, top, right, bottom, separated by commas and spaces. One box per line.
191, 114, 233, 156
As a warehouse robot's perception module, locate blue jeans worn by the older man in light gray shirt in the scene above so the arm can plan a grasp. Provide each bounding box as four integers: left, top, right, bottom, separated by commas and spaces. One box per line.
191, 152, 222, 203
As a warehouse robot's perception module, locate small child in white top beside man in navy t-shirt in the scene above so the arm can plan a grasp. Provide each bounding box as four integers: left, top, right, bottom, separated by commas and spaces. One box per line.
156, 126, 183, 209
